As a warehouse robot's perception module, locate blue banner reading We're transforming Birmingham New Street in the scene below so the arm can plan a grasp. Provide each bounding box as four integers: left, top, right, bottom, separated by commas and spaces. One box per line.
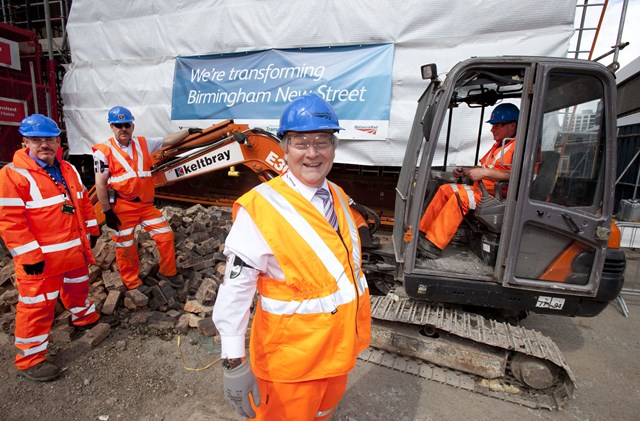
171, 44, 393, 139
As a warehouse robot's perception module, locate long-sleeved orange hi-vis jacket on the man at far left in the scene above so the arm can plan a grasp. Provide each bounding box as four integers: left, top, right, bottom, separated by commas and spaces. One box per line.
0, 149, 100, 279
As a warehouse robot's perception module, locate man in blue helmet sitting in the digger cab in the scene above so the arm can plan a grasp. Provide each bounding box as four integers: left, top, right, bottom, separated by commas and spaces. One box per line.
418, 104, 520, 259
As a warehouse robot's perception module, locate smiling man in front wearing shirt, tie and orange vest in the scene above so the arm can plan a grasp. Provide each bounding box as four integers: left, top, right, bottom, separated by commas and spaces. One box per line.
213, 94, 371, 421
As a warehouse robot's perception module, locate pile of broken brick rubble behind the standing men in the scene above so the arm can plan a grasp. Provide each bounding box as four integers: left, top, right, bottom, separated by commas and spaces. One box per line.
0, 205, 231, 342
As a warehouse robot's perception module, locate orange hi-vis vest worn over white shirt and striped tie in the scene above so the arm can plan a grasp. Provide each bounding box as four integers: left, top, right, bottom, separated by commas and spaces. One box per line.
234, 177, 371, 383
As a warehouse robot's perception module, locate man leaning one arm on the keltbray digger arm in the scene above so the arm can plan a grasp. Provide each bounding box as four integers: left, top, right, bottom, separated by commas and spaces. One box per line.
92, 106, 202, 289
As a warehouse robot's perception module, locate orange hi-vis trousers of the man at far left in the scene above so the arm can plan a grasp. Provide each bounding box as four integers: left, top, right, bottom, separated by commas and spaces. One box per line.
15, 266, 100, 370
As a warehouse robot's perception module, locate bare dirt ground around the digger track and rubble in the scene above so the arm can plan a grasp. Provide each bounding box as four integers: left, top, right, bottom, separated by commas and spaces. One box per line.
0, 251, 640, 421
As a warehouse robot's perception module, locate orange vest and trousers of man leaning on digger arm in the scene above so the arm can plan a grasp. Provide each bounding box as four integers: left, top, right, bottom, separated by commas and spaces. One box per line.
93, 136, 177, 289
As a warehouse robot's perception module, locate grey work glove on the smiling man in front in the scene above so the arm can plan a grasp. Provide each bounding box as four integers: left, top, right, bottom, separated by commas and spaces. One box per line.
222, 358, 260, 418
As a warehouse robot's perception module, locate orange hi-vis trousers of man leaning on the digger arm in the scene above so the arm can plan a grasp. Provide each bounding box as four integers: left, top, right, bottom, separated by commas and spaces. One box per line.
111, 198, 177, 289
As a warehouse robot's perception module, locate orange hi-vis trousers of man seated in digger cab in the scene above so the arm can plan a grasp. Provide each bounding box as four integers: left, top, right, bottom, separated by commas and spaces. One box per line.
420, 184, 482, 250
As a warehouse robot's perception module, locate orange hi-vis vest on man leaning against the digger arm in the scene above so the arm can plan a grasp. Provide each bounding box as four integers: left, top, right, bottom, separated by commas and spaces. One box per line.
92, 136, 155, 203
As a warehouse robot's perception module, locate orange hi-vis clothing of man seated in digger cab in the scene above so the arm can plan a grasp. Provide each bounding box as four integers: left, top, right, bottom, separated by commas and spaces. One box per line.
420, 139, 515, 250
